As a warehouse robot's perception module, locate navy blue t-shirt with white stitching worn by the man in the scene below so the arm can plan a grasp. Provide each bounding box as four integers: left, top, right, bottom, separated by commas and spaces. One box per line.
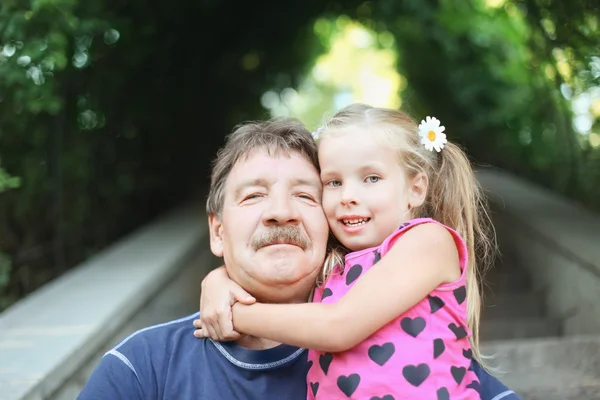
78, 313, 518, 400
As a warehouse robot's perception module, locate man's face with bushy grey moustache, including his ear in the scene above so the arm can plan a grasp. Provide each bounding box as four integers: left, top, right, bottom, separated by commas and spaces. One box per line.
209, 149, 329, 302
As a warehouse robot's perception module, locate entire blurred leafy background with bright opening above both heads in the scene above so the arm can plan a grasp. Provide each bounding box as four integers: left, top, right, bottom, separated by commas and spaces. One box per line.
0, 0, 600, 310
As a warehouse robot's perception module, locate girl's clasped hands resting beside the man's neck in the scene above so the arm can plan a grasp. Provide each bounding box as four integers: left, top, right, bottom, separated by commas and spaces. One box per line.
194, 266, 256, 341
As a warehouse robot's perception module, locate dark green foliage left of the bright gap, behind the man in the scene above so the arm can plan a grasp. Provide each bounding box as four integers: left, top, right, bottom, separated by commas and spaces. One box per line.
0, 0, 360, 309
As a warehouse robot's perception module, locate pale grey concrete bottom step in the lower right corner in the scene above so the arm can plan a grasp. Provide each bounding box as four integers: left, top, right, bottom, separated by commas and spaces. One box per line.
482, 336, 600, 400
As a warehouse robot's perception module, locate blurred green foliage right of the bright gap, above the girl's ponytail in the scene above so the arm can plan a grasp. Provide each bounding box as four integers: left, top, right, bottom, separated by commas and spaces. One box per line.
370, 0, 600, 207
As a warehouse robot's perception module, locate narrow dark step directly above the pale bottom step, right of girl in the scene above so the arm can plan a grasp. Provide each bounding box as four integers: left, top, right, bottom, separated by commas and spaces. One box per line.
480, 317, 562, 341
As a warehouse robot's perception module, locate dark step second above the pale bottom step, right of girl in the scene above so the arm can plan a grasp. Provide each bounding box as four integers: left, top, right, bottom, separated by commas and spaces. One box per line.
482, 292, 546, 320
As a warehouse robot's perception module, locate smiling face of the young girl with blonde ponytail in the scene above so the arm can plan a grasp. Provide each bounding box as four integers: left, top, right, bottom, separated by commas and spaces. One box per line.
319, 127, 409, 251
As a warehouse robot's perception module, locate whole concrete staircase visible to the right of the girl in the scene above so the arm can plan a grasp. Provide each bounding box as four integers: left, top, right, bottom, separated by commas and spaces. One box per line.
481, 255, 600, 400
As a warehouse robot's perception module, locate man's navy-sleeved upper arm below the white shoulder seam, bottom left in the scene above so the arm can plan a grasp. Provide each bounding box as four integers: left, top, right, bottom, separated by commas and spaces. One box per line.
77, 350, 146, 400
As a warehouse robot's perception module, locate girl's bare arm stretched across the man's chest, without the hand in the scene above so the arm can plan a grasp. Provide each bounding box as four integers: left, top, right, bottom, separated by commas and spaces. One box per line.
233, 223, 460, 352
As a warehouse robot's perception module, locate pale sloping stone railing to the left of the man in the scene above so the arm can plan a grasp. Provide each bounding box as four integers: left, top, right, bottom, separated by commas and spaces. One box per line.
0, 207, 214, 400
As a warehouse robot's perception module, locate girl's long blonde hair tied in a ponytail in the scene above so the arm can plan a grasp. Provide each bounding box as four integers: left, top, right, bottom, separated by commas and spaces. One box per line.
318, 104, 496, 363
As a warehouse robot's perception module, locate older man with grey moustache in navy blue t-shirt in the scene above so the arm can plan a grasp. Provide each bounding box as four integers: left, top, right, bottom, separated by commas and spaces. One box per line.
79, 120, 514, 400
